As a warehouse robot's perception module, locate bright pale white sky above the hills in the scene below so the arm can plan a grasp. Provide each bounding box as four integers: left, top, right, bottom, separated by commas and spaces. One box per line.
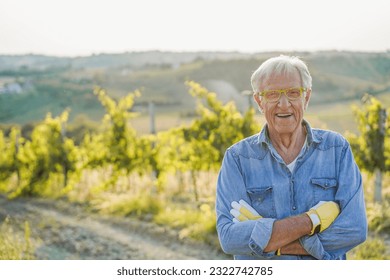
0, 0, 390, 56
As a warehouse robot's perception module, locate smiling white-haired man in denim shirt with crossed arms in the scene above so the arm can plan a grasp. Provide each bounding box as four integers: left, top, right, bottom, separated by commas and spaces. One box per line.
216, 56, 367, 260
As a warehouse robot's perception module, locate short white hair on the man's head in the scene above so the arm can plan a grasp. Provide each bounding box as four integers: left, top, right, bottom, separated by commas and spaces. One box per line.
251, 55, 312, 93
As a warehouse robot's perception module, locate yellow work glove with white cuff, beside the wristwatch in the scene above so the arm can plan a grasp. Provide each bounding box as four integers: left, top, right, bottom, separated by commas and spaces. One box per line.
306, 201, 340, 235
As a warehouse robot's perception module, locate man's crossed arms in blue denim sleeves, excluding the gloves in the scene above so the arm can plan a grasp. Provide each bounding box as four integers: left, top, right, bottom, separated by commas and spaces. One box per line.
216, 144, 367, 259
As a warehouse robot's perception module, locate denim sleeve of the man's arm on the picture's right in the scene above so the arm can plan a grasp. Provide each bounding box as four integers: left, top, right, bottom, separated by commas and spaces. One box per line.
300, 143, 367, 259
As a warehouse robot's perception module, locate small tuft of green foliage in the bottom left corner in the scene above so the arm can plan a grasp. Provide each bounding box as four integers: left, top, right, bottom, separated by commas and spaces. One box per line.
0, 217, 34, 260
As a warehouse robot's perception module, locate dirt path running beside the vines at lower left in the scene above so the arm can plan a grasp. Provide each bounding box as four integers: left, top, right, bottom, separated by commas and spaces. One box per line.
0, 196, 227, 260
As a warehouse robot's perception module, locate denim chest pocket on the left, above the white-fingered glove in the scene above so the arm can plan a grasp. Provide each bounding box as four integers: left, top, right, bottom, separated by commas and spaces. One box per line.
247, 186, 276, 218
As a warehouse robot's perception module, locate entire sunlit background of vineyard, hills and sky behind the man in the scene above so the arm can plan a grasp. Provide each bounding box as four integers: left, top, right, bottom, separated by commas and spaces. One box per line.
0, 0, 390, 259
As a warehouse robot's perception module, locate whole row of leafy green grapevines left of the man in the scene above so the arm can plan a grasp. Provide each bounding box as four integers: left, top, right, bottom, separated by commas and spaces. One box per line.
0, 82, 259, 205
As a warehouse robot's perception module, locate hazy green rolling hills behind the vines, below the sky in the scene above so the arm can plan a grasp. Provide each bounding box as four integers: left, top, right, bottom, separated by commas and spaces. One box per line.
0, 51, 390, 135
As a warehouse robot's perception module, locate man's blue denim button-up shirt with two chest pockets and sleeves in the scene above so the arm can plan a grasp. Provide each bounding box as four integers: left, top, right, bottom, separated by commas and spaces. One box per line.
216, 121, 367, 259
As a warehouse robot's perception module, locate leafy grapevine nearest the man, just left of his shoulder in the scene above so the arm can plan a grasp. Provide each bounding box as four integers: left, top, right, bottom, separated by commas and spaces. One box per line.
143, 81, 259, 201
